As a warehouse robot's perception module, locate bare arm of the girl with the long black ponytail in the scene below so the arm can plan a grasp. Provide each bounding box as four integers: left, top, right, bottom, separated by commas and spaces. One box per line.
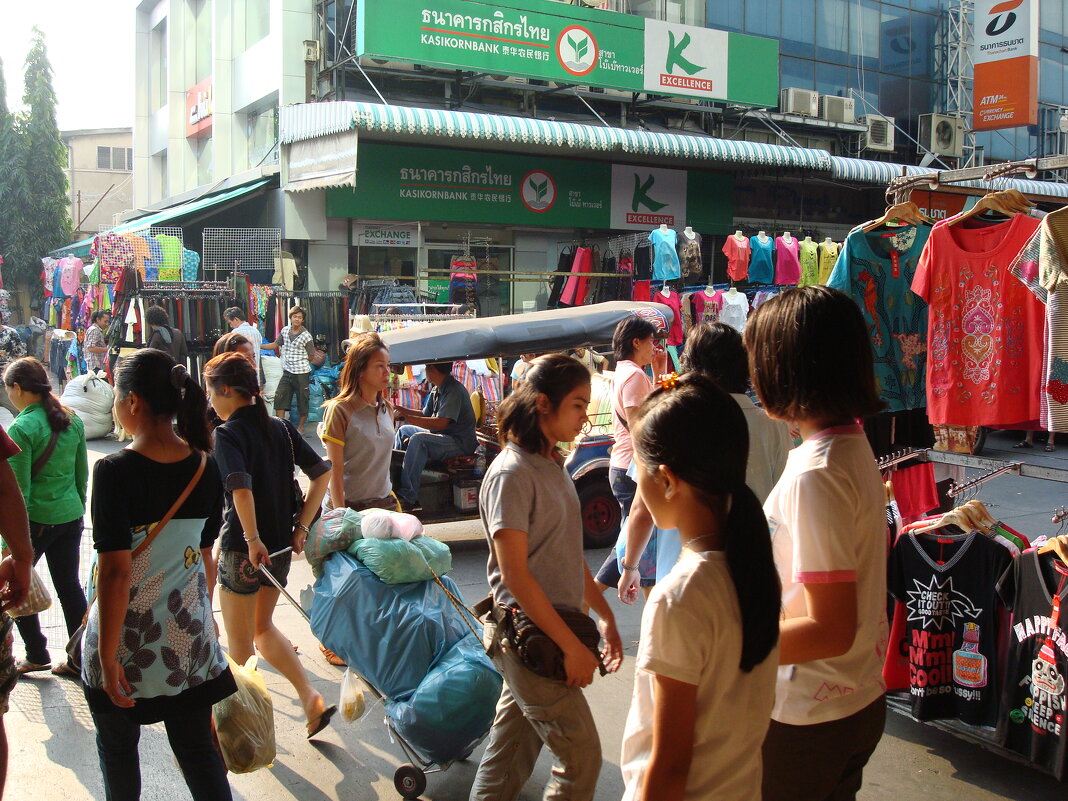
641, 674, 697, 801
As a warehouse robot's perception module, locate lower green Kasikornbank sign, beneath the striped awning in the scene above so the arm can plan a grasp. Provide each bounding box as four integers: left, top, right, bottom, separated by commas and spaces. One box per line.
327, 143, 734, 234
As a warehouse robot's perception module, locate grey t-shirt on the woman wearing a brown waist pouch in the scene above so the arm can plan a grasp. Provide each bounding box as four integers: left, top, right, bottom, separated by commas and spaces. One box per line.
478, 443, 585, 610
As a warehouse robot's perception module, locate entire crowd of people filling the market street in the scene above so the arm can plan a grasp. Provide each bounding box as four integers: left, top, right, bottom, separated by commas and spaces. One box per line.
0, 287, 888, 801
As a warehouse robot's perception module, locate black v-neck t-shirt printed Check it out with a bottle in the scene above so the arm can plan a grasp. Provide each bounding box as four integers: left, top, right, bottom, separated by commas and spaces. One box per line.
888, 532, 1012, 726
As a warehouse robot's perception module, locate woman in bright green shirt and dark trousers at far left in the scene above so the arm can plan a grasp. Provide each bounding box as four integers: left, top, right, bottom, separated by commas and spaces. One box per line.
3, 357, 89, 677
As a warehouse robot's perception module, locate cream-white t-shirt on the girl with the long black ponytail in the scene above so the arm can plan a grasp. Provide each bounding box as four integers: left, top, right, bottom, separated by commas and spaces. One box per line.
619, 550, 779, 801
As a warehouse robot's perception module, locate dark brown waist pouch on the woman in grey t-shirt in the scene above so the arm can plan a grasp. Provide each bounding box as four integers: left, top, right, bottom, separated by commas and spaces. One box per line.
475, 598, 608, 681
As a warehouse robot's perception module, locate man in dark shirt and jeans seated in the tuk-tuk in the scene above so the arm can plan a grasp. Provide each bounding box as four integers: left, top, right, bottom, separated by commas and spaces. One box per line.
394, 362, 478, 512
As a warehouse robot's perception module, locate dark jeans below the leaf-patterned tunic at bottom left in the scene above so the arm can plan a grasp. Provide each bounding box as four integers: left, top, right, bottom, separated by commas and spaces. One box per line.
90, 706, 233, 801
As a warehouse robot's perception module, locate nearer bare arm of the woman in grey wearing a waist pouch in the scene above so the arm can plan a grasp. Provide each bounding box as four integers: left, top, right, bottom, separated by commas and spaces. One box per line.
493, 529, 611, 687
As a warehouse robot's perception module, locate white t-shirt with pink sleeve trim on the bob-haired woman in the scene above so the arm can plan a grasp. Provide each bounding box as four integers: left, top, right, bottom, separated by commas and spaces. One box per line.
764, 426, 889, 725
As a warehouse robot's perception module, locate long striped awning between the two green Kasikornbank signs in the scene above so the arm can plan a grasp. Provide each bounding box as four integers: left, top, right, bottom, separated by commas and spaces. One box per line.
279, 103, 831, 171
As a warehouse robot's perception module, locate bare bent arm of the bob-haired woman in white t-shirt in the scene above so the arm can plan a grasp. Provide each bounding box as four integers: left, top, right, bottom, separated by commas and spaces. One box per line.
779, 581, 857, 664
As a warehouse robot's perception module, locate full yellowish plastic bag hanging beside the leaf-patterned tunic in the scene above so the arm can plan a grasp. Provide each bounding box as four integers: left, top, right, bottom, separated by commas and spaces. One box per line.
211, 654, 274, 773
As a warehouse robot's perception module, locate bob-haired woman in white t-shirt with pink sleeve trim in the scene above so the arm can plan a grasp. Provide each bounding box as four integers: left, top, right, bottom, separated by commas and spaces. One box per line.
745, 286, 888, 801
